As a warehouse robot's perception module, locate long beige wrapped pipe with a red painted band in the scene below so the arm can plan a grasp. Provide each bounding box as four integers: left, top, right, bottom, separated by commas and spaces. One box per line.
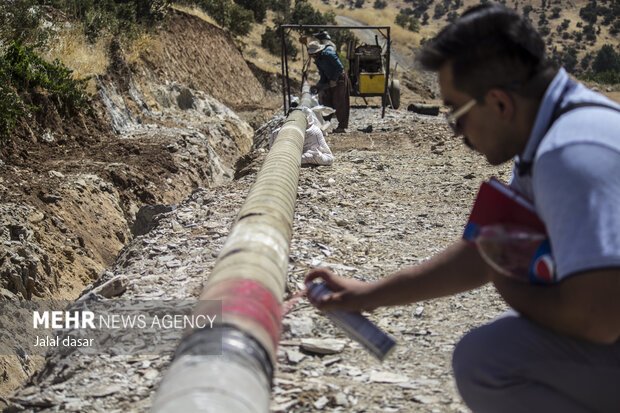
151, 82, 311, 413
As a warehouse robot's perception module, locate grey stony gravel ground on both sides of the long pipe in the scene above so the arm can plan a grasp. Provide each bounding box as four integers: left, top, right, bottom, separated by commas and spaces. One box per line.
8, 102, 509, 412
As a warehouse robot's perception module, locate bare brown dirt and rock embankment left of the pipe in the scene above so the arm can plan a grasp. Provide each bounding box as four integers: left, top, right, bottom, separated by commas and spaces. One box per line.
0, 7, 279, 405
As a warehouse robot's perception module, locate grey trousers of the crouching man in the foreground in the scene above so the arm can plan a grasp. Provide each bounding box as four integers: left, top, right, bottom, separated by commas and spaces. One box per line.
452, 311, 620, 413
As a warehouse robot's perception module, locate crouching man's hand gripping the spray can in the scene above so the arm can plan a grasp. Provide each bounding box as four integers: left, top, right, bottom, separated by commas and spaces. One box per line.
305, 267, 374, 311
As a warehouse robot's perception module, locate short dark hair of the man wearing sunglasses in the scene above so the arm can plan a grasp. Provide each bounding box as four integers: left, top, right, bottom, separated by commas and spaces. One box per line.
419, 3, 549, 99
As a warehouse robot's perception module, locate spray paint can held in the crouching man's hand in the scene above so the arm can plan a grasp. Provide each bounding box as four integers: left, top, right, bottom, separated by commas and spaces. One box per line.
306, 282, 396, 361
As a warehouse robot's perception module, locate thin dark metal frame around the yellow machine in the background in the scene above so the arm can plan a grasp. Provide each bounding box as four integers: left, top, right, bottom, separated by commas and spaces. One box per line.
280, 24, 392, 118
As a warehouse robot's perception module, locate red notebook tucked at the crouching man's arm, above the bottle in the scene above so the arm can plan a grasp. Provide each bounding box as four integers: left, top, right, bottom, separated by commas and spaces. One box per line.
463, 178, 546, 241
